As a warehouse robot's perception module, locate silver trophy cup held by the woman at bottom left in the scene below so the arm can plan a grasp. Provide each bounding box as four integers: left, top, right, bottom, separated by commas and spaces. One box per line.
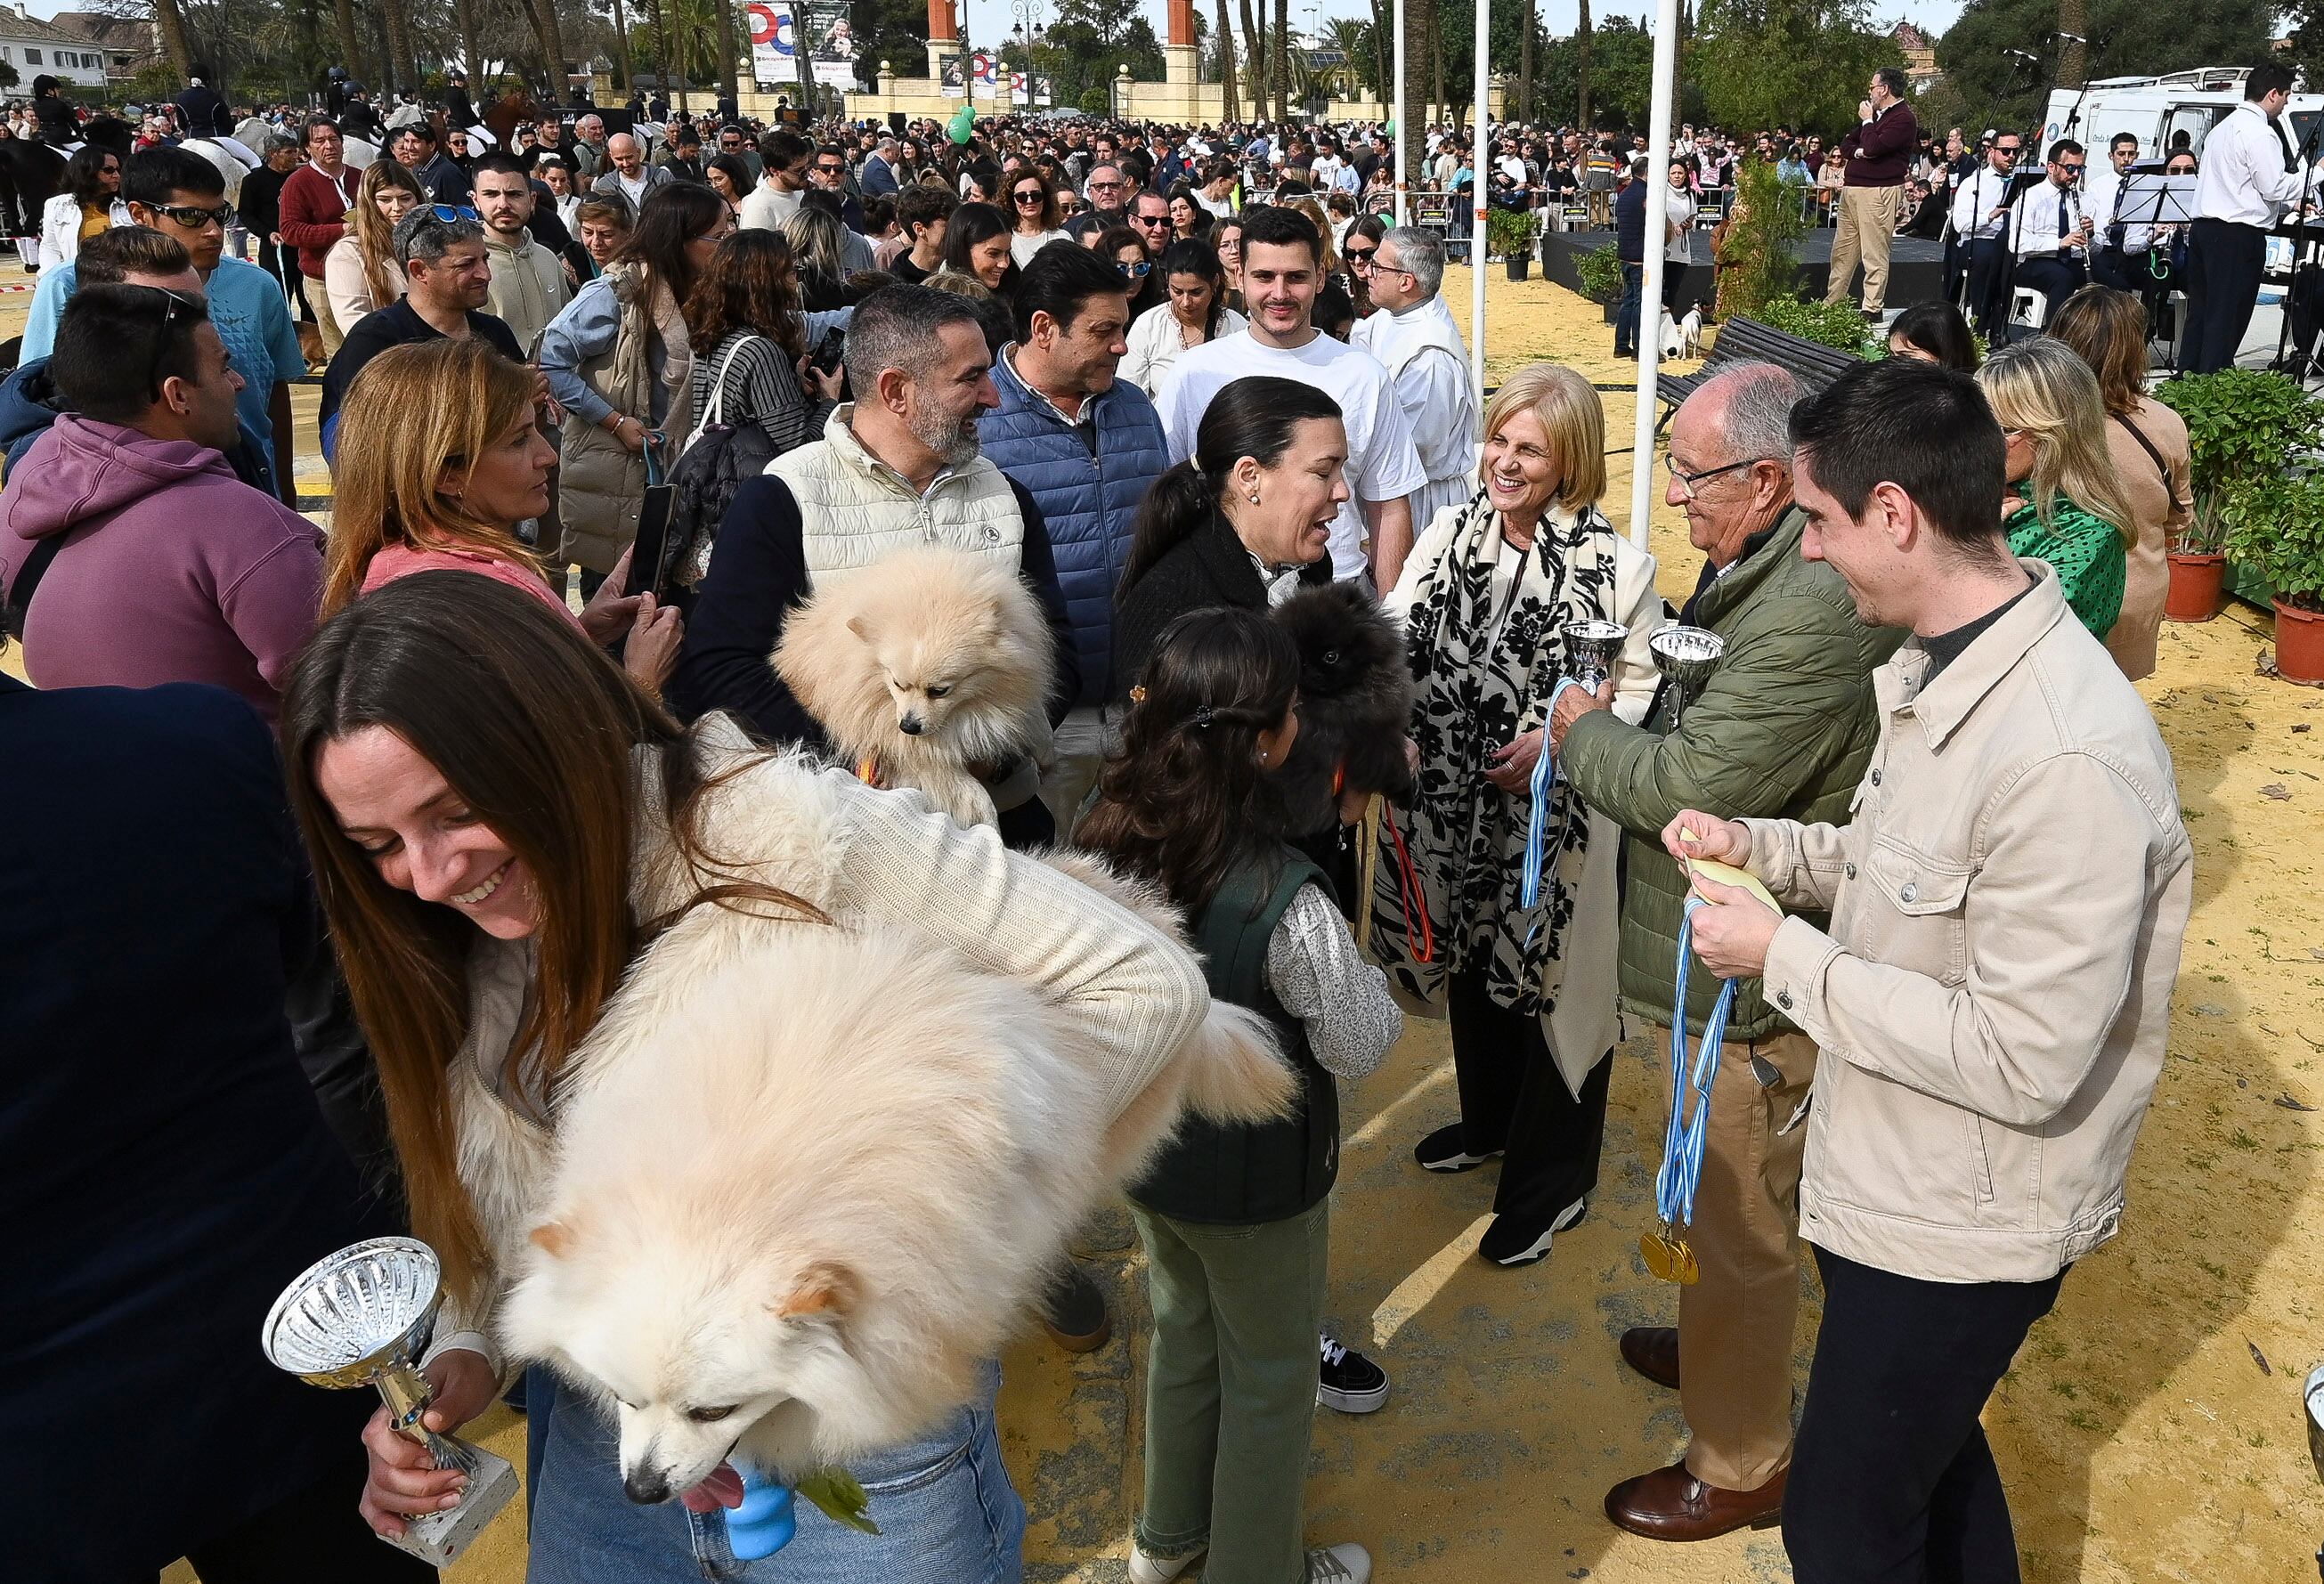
258, 1238, 516, 1568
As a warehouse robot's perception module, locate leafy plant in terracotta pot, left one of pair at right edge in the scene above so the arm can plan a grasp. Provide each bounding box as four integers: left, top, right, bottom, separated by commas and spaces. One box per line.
2154, 370, 2324, 622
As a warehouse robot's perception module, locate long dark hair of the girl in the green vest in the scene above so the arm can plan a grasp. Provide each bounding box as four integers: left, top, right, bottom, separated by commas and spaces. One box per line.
1074, 608, 1299, 913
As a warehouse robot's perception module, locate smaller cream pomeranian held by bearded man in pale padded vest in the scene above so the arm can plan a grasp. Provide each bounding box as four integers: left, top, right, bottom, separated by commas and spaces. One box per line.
774, 546, 1058, 824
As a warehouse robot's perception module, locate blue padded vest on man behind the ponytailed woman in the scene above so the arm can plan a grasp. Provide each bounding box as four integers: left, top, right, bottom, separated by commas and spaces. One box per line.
976, 357, 1169, 703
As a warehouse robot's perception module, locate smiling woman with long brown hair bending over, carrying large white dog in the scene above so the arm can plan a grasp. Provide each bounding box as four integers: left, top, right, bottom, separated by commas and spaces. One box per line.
283, 572, 1227, 1584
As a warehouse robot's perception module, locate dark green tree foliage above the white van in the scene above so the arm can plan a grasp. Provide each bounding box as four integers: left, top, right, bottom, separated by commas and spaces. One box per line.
1936, 0, 2268, 138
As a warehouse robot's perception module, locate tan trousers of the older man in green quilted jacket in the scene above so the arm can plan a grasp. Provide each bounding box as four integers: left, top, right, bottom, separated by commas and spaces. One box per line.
1654, 1029, 1815, 1491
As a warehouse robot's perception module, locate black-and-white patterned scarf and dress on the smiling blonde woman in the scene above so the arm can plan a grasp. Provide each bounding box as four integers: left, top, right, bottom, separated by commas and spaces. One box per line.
1374, 490, 1615, 1012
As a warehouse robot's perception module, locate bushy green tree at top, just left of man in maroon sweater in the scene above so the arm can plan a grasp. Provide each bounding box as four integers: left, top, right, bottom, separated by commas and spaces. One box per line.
1687, 0, 1904, 133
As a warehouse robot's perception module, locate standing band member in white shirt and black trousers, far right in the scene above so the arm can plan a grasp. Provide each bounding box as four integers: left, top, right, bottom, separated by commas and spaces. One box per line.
2180, 62, 2308, 374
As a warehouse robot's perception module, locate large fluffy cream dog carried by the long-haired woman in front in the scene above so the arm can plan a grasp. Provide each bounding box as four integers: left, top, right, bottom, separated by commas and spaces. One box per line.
500, 855, 1296, 1522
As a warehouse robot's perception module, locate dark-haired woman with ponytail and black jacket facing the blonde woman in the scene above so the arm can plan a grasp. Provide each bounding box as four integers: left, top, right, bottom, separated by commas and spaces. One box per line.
1113, 374, 1348, 699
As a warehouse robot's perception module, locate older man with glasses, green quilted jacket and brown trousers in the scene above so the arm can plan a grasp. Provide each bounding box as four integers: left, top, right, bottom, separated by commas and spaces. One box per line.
1550, 362, 1904, 1539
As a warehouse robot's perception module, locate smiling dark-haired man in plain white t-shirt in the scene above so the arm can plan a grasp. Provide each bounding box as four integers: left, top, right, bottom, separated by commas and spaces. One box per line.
1155, 207, 1427, 590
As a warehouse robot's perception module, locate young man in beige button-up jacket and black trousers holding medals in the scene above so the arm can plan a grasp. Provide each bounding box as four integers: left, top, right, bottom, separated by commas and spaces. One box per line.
1664, 360, 2194, 1584
